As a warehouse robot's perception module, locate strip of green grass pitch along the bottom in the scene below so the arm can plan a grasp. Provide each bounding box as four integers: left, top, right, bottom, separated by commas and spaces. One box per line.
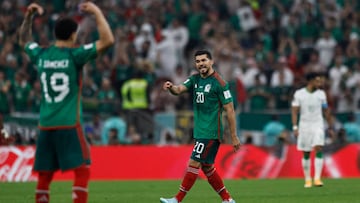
0, 179, 360, 203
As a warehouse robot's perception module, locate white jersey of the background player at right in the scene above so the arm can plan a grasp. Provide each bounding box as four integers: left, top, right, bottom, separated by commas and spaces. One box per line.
291, 87, 327, 126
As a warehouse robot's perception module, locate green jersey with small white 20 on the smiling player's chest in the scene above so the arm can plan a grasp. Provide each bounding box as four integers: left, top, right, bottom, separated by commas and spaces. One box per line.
184, 72, 233, 140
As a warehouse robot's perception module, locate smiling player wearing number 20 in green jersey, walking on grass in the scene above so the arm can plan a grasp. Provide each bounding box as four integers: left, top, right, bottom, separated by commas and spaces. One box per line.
160, 50, 240, 203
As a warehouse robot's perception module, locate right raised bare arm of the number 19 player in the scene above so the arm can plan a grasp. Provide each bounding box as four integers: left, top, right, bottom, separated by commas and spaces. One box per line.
80, 2, 115, 53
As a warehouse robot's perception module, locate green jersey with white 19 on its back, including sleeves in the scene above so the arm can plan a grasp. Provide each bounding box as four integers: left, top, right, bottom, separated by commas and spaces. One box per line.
25, 42, 97, 129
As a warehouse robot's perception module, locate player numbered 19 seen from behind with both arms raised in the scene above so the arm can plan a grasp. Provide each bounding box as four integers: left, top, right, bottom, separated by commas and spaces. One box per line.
19, 2, 114, 203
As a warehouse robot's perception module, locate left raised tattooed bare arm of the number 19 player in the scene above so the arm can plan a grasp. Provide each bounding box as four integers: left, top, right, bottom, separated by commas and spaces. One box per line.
19, 3, 44, 47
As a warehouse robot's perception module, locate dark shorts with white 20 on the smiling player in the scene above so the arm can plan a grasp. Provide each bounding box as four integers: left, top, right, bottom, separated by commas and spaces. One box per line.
191, 139, 220, 164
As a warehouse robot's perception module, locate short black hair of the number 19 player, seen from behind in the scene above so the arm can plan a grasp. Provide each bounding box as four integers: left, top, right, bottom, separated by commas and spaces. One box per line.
54, 17, 78, 40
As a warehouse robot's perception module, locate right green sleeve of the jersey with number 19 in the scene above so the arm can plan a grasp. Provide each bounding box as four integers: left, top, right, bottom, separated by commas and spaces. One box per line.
73, 42, 97, 66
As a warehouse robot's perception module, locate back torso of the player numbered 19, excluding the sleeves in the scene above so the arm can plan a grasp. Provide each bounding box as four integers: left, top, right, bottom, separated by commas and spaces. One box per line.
37, 46, 81, 127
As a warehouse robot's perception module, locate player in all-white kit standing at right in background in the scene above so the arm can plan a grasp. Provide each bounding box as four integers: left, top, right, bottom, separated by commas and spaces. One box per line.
291, 73, 333, 188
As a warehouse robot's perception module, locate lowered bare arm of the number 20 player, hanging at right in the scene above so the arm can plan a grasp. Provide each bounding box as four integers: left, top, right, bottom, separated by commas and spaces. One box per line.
224, 102, 241, 151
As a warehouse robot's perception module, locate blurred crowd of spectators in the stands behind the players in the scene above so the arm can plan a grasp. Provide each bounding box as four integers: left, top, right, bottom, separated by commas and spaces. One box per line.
0, 0, 360, 146
